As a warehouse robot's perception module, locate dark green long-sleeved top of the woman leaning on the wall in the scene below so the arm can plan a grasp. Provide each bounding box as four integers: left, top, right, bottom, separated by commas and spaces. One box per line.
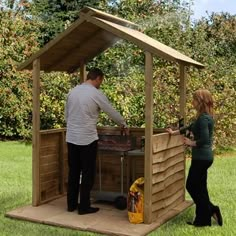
180, 113, 214, 161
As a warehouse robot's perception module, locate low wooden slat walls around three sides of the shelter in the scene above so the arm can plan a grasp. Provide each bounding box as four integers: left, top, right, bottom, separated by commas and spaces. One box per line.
39, 125, 188, 221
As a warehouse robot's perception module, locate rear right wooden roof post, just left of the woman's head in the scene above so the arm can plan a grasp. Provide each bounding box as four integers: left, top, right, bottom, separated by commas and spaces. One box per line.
179, 64, 186, 124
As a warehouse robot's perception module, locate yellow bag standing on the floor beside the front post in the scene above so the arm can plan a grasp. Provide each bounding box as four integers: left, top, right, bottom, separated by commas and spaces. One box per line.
128, 177, 144, 224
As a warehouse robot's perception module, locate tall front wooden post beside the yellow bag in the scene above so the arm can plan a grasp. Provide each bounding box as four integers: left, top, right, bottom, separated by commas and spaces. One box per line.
144, 52, 153, 224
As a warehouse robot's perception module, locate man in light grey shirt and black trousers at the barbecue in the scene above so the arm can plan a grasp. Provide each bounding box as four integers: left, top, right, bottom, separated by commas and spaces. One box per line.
65, 68, 128, 215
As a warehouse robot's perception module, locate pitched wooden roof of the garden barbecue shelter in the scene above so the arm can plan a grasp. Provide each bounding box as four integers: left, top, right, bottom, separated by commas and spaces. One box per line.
18, 7, 204, 72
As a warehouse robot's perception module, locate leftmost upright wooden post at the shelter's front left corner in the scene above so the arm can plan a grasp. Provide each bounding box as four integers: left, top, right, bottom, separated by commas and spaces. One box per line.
32, 59, 40, 206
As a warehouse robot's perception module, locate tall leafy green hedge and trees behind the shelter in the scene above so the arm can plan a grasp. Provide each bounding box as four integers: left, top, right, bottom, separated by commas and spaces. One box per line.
0, 0, 236, 147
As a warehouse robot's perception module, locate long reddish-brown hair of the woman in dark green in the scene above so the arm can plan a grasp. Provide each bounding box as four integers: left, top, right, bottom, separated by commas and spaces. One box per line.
193, 89, 213, 116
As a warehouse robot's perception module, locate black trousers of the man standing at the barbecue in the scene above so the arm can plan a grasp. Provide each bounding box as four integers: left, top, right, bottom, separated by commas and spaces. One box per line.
67, 140, 97, 210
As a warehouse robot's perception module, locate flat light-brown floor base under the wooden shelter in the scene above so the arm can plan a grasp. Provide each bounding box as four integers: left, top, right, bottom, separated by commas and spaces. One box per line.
6, 197, 192, 236
